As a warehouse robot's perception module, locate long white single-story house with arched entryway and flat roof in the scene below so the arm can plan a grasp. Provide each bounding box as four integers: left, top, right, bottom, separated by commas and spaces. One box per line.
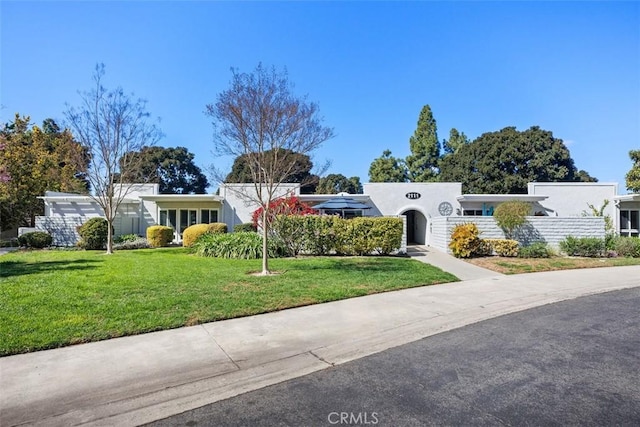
31, 182, 640, 250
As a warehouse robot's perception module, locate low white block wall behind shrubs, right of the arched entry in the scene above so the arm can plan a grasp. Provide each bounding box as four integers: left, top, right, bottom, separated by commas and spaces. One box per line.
431, 216, 605, 253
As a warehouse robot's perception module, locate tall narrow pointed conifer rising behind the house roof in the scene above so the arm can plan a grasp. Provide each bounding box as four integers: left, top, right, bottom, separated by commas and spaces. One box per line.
406, 105, 440, 182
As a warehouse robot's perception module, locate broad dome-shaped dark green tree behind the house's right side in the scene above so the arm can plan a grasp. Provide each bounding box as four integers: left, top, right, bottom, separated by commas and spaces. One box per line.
440, 126, 595, 194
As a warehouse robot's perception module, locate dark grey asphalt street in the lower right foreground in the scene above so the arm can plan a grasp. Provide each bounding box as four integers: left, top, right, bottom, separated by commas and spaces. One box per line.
149, 287, 640, 427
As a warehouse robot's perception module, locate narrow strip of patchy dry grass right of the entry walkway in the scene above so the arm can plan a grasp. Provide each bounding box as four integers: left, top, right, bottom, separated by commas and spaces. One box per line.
466, 256, 640, 274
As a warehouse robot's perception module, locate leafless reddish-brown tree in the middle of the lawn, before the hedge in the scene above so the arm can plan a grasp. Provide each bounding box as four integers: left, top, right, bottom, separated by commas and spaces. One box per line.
205, 64, 334, 275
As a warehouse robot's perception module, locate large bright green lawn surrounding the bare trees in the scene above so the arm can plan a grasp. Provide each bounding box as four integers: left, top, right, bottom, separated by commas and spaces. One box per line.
0, 248, 457, 356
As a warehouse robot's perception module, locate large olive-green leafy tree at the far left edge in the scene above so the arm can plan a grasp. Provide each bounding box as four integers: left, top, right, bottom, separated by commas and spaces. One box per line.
0, 114, 89, 229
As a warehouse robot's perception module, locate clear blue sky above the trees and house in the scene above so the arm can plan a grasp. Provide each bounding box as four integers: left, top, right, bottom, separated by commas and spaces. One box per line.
0, 1, 640, 193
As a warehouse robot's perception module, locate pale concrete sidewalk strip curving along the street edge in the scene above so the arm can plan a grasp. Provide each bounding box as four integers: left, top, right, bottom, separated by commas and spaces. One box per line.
0, 266, 640, 426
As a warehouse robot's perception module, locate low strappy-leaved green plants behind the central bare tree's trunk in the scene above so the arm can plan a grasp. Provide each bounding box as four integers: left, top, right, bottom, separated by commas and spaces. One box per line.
193, 231, 283, 259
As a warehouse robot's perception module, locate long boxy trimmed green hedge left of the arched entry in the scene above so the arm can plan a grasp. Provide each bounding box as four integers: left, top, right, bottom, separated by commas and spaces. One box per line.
271, 215, 403, 256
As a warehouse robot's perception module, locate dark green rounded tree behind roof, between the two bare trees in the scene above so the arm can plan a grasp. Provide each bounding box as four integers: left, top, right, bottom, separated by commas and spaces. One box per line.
120, 147, 209, 194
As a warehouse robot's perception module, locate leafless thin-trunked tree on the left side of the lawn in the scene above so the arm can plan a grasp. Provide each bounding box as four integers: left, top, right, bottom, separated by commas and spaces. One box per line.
64, 64, 162, 254
